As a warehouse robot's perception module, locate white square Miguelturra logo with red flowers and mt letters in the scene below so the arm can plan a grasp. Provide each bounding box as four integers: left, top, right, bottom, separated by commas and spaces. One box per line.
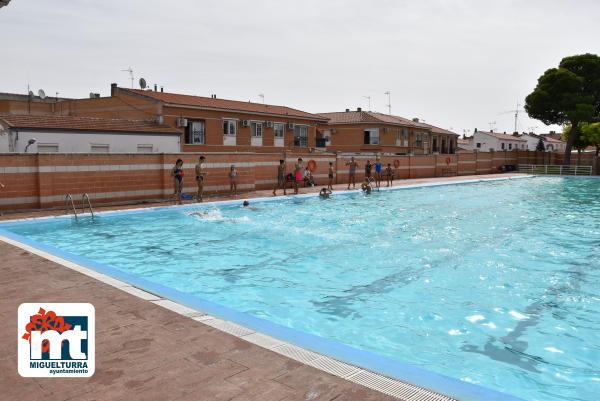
18, 303, 96, 377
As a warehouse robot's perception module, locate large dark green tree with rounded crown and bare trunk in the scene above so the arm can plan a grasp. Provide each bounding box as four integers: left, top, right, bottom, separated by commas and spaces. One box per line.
525, 53, 600, 165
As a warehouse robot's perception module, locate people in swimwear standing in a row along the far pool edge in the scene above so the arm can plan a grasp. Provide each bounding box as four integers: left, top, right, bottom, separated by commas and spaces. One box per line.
171, 156, 394, 204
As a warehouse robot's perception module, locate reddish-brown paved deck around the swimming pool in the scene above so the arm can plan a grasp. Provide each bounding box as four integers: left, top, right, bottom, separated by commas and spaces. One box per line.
0, 174, 520, 401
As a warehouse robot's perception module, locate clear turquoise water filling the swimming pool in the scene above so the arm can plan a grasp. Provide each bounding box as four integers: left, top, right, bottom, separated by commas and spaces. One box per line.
3, 178, 600, 401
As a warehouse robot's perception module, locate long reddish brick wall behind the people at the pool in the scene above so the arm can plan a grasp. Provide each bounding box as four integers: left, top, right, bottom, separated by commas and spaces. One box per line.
0, 151, 598, 210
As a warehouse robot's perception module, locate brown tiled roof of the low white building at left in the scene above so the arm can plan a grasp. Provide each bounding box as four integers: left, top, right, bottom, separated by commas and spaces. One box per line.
0, 114, 181, 134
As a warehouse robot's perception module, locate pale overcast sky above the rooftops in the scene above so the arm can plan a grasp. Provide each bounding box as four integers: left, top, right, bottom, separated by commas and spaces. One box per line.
0, 0, 600, 134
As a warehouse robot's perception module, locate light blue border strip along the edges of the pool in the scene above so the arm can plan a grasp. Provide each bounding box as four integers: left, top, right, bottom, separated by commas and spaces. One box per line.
0, 176, 564, 401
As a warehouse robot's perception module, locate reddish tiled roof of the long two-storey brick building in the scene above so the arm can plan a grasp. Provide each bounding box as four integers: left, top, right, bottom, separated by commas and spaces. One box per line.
119, 88, 324, 120
